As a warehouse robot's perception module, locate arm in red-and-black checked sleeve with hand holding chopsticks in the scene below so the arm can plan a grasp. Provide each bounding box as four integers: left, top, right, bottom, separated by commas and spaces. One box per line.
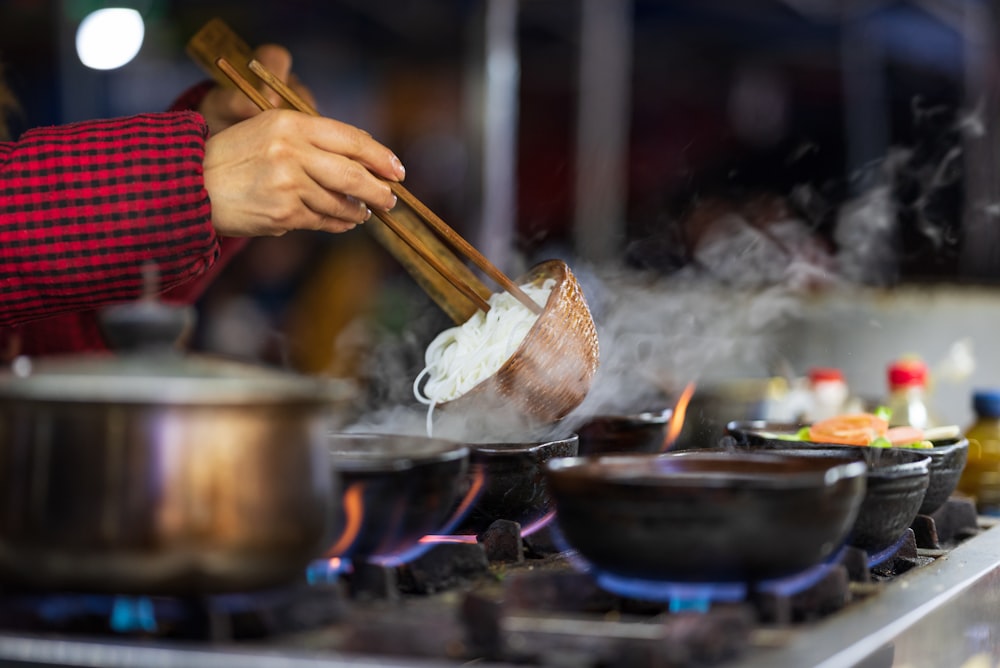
0, 42, 403, 354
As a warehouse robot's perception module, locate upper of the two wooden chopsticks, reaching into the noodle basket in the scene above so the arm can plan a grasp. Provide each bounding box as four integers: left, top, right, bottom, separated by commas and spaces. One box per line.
247, 58, 542, 314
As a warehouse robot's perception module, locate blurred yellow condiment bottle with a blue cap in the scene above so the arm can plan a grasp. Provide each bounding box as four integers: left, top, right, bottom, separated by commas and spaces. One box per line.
958, 389, 1000, 515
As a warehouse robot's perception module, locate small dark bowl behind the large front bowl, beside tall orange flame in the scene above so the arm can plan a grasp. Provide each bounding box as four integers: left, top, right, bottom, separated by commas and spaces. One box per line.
576, 408, 674, 457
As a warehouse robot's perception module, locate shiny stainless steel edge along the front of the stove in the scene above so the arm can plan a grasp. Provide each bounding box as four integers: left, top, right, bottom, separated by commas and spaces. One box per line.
0, 525, 1000, 668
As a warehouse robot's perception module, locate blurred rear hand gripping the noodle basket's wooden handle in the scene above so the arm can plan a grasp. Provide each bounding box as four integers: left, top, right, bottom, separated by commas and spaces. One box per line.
198, 44, 316, 135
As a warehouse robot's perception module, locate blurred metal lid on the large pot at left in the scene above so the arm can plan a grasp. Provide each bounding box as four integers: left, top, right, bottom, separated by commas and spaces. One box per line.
0, 352, 356, 405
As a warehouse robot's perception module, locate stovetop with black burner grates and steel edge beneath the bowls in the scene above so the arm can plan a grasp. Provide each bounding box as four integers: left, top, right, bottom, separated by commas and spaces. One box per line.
0, 508, 1000, 668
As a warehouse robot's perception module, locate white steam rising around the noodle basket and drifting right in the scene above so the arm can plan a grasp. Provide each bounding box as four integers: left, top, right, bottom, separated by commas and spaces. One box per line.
342, 96, 982, 440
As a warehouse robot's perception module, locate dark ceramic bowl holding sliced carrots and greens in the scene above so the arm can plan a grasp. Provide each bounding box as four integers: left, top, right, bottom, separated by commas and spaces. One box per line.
726, 420, 969, 515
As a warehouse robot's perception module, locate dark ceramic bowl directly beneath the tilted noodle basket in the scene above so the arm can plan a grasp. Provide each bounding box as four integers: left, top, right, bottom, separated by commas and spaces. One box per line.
452, 434, 579, 534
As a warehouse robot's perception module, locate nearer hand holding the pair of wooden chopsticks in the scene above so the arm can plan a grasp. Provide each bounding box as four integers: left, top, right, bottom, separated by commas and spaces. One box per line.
203, 109, 406, 237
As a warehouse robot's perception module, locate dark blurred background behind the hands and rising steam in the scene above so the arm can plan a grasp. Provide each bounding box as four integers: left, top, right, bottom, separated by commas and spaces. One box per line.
0, 0, 1000, 421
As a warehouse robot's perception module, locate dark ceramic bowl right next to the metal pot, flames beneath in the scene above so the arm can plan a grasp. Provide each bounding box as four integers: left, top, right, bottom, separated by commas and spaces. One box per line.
327, 434, 469, 559
